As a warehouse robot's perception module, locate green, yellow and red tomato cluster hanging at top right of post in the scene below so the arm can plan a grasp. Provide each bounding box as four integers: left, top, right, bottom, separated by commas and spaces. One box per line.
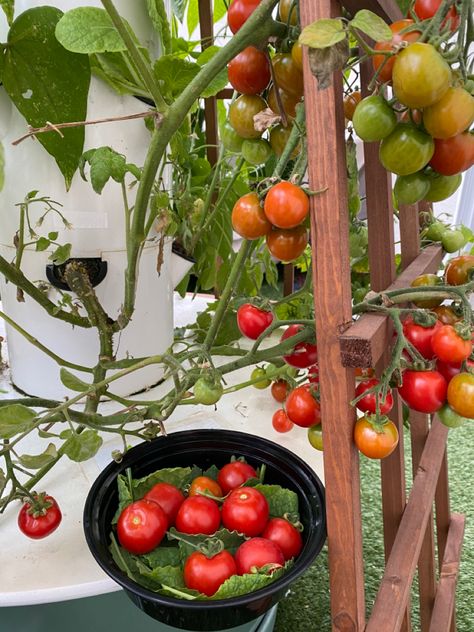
345, 13, 474, 205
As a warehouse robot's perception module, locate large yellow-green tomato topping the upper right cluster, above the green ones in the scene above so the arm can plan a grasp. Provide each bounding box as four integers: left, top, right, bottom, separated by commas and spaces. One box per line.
392, 42, 451, 108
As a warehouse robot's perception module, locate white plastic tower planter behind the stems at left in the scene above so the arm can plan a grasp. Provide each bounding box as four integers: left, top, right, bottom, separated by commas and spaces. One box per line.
0, 0, 191, 398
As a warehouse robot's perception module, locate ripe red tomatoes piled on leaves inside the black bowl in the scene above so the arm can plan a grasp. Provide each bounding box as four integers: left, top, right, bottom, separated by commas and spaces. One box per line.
113, 460, 303, 597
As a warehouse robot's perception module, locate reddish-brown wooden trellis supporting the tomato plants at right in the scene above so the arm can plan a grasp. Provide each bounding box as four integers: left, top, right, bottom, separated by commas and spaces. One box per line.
199, 0, 464, 632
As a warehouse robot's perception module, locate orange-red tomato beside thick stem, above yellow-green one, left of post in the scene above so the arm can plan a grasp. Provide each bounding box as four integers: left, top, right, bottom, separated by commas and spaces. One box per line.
227, 46, 270, 94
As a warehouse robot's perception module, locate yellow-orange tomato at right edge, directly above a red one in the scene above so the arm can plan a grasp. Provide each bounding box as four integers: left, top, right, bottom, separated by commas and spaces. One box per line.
423, 87, 474, 138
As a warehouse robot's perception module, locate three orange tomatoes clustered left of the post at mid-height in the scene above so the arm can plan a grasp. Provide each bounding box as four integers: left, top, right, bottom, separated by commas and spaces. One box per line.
232, 181, 309, 261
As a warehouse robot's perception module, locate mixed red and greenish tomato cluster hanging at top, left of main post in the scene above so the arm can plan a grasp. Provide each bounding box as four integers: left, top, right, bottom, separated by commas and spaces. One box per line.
221, 0, 303, 166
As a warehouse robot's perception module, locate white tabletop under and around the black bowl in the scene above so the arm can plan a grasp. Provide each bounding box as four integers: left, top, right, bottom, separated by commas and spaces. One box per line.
0, 295, 323, 606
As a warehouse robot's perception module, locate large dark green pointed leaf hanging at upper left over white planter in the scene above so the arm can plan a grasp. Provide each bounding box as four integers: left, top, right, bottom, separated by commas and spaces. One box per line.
3, 6, 91, 189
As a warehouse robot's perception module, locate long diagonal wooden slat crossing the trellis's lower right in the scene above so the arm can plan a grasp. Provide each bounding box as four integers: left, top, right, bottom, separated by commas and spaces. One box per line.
366, 418, 448, 632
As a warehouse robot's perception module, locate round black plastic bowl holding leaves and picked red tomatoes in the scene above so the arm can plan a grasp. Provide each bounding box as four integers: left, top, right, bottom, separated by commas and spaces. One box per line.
84, 430, 326, 631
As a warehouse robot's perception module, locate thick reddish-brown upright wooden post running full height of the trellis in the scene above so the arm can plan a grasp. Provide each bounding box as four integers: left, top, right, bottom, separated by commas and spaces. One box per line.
300, 0, 365, 632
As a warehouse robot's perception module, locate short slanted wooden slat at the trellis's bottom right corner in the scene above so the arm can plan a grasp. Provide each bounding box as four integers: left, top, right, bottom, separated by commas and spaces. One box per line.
429, 513, 465, 632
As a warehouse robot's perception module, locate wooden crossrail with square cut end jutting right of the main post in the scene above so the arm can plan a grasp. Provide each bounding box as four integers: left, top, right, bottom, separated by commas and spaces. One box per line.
339, 245, 444, 368
